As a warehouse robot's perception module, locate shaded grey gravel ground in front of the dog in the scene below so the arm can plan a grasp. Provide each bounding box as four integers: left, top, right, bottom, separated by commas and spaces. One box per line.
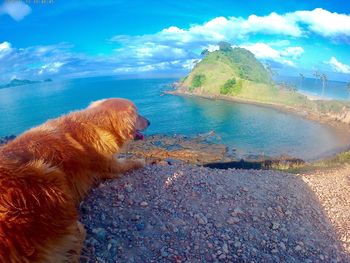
81, 163, 350, 262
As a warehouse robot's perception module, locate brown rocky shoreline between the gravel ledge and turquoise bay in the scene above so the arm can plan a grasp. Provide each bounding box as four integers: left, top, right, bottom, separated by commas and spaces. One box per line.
0, 135, 305, 170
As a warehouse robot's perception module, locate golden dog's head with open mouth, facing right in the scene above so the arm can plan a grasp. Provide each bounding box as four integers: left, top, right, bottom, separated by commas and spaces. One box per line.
89, 98, 150, 140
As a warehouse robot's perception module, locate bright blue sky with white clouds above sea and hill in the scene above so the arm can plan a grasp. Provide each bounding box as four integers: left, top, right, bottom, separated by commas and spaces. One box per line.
0, 0, 350, 83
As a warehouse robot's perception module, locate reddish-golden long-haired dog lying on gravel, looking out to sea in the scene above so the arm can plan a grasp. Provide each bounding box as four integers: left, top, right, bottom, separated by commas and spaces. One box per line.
0, 99, 149, 263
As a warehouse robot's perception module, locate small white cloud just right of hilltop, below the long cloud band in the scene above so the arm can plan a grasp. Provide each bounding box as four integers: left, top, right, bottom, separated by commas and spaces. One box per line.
240, 43, 304, 67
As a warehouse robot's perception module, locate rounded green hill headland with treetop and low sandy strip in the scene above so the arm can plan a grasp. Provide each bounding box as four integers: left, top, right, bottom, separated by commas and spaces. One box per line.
169, 42, 350, 127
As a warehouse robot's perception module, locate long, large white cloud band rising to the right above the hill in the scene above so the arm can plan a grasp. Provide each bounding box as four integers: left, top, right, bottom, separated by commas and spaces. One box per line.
112, 8, 350, 53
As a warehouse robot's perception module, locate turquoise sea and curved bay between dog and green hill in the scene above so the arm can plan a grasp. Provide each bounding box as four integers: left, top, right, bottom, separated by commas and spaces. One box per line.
0, 77, 349, 159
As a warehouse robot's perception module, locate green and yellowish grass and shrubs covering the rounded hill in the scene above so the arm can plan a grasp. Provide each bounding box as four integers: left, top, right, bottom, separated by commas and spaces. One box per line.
181, 43, 350, 113
